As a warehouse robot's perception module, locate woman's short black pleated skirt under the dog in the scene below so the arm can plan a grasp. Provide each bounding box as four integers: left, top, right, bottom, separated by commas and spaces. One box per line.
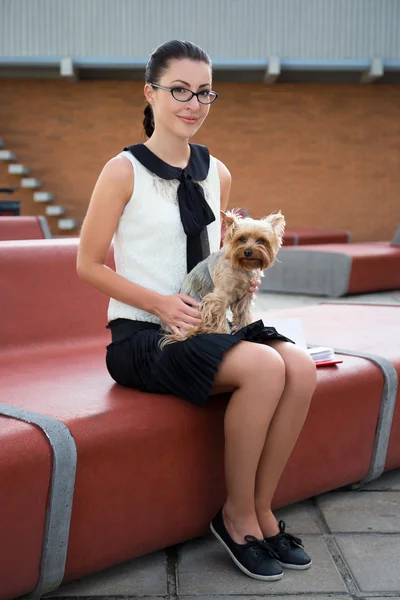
106, 319, 294, 406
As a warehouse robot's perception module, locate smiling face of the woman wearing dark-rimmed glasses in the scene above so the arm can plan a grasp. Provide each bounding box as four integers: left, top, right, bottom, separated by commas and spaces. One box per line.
144, 58, 211, 138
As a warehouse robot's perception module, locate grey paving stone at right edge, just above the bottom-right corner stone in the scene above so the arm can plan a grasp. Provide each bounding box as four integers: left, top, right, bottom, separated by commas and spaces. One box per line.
317, 491, 400, 533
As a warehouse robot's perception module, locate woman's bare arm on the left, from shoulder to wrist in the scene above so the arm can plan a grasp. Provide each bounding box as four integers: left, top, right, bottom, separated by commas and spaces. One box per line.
76, 156, 162, 314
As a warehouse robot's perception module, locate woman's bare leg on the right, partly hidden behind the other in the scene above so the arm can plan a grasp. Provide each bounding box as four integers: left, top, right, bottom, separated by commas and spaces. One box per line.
255, 341, 317, 537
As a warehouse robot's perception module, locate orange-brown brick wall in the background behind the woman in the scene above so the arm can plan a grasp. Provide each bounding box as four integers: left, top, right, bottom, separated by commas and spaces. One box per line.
0, 79, 400, 241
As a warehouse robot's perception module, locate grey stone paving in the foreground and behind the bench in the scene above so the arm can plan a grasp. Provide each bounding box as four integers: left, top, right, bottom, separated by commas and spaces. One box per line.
48, 291, 400, 600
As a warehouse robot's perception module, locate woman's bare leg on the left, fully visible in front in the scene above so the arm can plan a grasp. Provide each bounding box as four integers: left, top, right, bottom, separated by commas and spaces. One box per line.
212, 342, 285, 544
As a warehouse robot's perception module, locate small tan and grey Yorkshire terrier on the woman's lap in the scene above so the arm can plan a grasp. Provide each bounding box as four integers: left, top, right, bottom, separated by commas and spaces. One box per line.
161, 211, 286, 347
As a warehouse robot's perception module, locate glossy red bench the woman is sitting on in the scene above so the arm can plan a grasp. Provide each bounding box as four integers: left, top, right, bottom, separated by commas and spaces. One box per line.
0, 238, 397, 600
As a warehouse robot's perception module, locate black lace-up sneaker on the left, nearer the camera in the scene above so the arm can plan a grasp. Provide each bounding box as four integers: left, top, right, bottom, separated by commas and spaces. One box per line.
210, 508, 283, 581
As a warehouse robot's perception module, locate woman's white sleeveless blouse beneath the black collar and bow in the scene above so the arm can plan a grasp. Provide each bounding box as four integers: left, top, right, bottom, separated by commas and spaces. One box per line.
107, 151, 221, 323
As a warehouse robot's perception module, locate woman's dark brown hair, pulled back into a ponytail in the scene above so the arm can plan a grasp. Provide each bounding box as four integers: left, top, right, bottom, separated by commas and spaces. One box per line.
143, 40, 211, 137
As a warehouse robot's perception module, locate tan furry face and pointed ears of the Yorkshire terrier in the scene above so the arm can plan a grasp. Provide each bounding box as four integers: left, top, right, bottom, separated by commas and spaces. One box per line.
221, 211, 286, 271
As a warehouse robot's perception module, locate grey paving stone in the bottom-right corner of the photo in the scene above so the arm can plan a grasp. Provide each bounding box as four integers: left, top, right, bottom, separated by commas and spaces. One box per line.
335, 533, 400, 598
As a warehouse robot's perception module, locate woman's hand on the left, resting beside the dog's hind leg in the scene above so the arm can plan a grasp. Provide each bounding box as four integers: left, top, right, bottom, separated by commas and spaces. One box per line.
155, 294, 202, 335
